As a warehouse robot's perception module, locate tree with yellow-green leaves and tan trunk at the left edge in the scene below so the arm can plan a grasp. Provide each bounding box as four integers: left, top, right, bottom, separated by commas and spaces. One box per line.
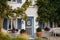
0, 0, 12, 32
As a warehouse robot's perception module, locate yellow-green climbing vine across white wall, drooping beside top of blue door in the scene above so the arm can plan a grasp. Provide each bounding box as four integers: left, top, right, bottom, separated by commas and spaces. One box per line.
13, 1, 31, 21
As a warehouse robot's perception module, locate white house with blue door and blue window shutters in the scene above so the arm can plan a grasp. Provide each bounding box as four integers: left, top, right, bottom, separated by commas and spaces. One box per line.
3, 0, 59, 37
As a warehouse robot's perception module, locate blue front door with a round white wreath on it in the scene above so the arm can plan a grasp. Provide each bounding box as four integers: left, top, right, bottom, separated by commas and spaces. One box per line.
25, 17, 34, 37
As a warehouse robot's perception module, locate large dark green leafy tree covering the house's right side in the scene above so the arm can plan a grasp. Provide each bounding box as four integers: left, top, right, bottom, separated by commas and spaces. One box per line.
36, 0, 60, 27
